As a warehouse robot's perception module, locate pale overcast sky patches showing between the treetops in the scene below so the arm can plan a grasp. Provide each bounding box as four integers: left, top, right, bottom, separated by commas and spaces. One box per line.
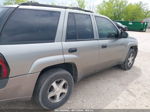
0, 0, 150, 9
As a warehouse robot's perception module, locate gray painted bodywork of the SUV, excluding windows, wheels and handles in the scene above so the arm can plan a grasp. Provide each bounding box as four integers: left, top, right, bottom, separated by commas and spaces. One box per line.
0, 6, 137, 100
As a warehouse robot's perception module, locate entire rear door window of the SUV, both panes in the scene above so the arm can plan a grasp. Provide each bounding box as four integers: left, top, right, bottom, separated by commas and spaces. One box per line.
67, 13, 94, 40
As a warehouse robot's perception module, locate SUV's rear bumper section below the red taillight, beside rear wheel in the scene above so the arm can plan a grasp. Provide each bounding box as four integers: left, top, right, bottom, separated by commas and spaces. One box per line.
0, 73, 39, 101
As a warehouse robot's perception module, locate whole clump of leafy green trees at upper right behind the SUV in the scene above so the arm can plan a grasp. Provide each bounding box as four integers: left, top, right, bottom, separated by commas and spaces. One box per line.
97, 0, 150, 21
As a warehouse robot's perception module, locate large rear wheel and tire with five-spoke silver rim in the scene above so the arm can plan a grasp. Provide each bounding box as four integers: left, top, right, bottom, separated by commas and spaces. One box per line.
33, 69, 74, 110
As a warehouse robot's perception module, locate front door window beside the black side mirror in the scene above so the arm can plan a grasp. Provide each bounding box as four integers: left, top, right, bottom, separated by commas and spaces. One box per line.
95, 17, 118, 38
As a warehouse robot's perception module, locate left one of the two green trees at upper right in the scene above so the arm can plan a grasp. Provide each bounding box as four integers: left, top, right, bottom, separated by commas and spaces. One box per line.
97, 0, 127, 20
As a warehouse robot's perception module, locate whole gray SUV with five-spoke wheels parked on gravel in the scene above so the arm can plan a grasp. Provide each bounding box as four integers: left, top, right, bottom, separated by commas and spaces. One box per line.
0, 3, 138, 110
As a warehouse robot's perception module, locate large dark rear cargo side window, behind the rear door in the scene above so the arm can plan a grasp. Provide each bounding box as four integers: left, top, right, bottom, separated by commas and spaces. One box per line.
0, 9, 60, 44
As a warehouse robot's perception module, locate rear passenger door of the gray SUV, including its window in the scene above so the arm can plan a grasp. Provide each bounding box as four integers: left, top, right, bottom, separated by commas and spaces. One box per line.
63, 11, 99, 79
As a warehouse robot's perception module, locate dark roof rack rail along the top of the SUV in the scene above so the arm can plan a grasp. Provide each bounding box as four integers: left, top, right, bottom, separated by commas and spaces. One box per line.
19, 1, 93, 13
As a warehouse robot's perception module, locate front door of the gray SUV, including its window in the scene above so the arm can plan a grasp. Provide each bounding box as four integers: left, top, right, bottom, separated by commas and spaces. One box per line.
95, 16, 125, 69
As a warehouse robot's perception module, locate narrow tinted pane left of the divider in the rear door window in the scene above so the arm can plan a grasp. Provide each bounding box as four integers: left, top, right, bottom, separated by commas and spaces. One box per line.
67, 14, 77, 40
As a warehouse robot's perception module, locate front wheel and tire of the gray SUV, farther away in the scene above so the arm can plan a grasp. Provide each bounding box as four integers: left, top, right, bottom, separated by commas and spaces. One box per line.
121, 49, 137, 70
